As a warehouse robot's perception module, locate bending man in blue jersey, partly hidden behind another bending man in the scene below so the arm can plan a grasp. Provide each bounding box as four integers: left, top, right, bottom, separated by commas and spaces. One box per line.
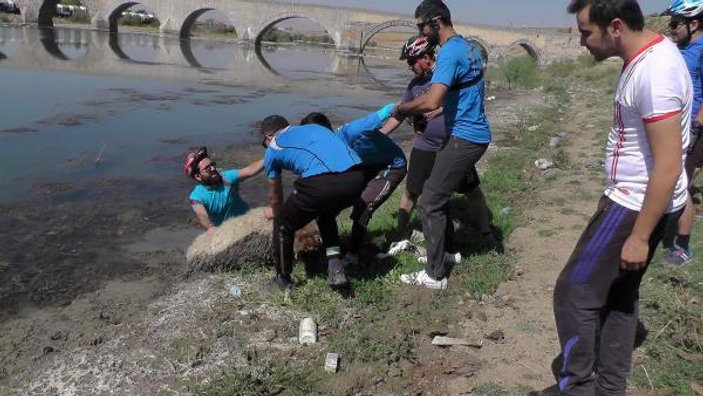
300, 104, 407, 264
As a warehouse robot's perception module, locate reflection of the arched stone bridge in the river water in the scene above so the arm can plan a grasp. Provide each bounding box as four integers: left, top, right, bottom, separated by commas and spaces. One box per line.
0, 27, 405, 88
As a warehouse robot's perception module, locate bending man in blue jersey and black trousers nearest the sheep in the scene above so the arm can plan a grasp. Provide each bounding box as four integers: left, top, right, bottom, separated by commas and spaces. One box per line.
261, 115, 365, 288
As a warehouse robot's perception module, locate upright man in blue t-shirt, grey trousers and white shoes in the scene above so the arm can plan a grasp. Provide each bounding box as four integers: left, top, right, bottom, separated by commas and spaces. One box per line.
394, 0, 491, 289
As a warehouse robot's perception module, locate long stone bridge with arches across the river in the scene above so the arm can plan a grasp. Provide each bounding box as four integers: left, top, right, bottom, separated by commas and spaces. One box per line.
19, 0, 582, 63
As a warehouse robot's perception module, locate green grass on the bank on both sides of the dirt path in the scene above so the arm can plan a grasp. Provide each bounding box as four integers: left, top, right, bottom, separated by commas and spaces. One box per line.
195, 58, 703, 395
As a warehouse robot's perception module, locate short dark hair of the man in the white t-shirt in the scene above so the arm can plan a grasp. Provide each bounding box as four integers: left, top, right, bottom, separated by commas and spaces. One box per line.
567, 0, 644, 32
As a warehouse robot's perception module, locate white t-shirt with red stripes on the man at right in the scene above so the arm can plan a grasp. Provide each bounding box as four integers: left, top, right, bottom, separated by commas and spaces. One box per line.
605, 36, 693, 213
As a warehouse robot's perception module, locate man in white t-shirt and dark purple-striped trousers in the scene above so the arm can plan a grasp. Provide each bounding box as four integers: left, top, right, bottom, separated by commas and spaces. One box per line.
554, 0, 693, 396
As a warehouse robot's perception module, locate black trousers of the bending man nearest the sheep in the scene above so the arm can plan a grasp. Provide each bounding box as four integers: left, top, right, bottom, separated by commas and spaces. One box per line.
273, 168, 366, 275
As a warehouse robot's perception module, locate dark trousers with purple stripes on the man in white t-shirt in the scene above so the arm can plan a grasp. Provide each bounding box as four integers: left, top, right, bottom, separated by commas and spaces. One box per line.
554, 196, 682, 396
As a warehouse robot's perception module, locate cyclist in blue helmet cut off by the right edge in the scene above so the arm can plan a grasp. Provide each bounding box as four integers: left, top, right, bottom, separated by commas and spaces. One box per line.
664, 0, 703, 265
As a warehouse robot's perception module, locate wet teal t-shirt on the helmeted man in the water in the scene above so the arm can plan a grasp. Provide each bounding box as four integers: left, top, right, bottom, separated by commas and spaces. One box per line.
190, 169, 249, 226
